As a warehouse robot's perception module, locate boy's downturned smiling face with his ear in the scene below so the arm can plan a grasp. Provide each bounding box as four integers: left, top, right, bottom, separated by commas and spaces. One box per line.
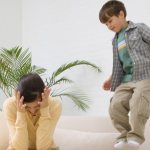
105, 11, 127, 33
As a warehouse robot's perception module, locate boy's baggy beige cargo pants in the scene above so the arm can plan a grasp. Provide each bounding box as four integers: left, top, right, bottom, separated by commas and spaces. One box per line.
109, 79, 150, 144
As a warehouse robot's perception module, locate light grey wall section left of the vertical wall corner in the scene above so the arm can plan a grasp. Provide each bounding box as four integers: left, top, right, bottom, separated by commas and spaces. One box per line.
0, 0, 22, 108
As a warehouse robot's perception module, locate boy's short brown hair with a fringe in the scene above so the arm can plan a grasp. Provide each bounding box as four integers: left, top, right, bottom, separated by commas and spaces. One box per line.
99, 0, 127, 23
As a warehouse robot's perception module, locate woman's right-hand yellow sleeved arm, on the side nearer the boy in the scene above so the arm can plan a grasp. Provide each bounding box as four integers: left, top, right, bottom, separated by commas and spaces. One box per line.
36, 99, 62, 150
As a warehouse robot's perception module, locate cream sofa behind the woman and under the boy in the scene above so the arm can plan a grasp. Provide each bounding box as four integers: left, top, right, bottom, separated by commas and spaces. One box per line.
0, 112, 150, 150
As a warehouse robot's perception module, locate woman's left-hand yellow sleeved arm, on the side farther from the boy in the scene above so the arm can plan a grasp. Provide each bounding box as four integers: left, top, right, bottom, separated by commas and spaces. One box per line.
3, 100, 28, 150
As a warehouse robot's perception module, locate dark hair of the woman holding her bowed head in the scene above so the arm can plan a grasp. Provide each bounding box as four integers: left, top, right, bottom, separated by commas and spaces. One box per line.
17, 73, 45, 102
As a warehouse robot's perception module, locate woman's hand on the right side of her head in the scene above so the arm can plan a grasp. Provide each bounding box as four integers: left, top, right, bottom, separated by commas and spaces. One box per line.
38, 87, 50, 108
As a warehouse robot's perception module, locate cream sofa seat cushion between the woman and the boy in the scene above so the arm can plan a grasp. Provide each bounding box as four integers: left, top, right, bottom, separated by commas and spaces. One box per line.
54, 129, 118, 150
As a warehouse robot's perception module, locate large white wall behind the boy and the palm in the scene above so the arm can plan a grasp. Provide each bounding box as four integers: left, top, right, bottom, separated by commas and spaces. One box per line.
0, 0, 150, 115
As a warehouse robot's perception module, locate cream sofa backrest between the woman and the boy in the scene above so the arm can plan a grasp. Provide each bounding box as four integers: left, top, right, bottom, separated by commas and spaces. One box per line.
57, 116, 117, 132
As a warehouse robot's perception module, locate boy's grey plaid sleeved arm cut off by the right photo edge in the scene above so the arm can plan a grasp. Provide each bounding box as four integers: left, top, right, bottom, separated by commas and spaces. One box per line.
139, 23, 150, 44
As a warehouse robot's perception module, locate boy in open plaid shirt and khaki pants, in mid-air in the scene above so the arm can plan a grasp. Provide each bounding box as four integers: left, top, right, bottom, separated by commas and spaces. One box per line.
99, 0, 150, 148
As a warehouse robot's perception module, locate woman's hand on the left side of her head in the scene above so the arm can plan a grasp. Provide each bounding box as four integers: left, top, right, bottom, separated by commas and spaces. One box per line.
15, 90, 26, 112
